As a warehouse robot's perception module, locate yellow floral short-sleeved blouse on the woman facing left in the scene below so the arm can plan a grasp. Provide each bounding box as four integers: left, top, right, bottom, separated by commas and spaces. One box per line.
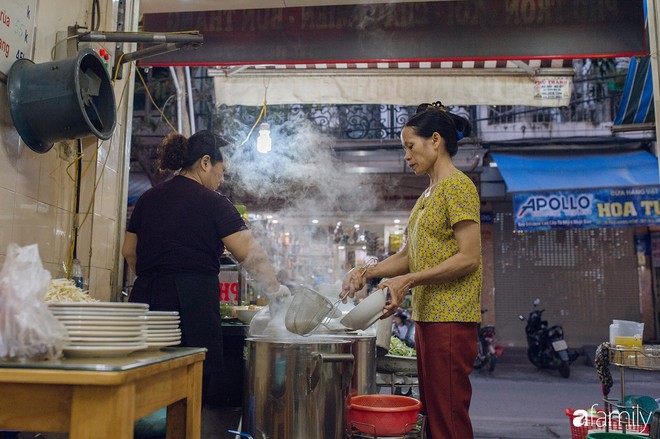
407, 171, 482, 322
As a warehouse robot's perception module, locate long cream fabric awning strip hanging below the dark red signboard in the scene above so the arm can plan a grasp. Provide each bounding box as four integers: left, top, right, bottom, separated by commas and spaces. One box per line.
214, 68, 574, 107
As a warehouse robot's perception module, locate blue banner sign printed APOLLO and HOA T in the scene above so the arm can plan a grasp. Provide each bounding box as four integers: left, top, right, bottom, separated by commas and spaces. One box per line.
513, 186, 660, 230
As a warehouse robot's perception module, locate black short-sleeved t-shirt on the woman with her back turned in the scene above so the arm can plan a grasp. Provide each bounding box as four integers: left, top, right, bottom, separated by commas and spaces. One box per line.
126, 176, 247, 276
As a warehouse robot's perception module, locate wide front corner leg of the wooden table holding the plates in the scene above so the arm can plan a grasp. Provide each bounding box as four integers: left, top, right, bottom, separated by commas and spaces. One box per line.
69, 383, 135, 439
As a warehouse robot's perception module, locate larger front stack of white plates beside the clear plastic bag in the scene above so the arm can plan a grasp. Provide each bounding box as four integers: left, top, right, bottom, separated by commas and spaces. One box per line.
48, 302, 149, 357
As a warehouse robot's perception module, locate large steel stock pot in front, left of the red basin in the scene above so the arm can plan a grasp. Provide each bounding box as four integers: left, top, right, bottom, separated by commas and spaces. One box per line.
243, 336, 354, 439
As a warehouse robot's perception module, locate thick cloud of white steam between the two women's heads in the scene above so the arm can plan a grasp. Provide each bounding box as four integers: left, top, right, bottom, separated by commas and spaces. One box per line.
226, 120, 376, 217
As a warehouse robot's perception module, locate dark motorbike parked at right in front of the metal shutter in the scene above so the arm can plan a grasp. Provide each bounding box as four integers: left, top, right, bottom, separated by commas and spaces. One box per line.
519, 299, 577, 378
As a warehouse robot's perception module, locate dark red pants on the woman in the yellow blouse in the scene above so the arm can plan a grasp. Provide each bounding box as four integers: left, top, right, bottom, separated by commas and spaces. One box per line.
415, 322, 477, 439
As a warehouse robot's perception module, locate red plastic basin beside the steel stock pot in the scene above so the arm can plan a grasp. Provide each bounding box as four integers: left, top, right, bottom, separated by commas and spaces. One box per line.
348, 394, 422, 436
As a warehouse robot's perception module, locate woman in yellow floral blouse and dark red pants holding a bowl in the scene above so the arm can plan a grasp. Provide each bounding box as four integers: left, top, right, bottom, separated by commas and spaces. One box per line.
344, 102, 482, 439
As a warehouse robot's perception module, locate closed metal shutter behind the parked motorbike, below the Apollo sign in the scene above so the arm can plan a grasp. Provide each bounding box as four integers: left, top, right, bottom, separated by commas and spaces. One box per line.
493, 205, 640, 347
